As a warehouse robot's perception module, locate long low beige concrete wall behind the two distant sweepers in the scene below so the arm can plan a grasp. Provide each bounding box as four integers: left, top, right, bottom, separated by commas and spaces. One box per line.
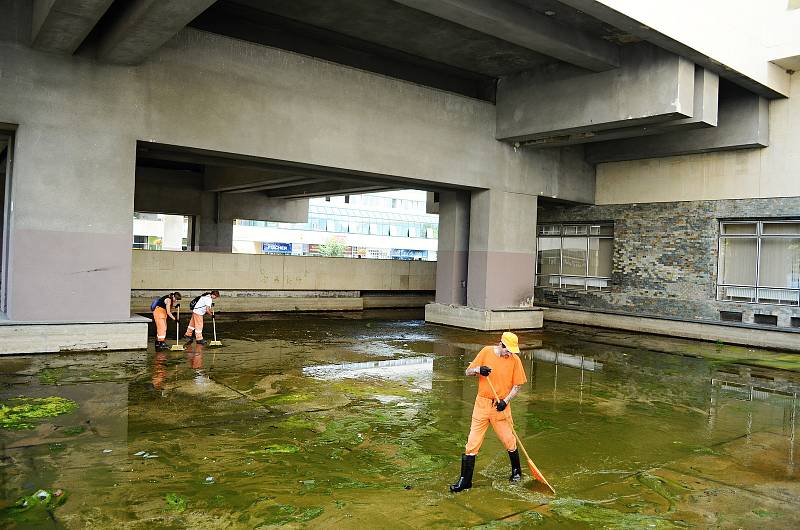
129, 250, 436, 292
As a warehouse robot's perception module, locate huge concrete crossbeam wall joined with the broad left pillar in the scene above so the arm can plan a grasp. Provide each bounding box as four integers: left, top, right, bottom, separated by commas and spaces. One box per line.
0, 16, 594, 320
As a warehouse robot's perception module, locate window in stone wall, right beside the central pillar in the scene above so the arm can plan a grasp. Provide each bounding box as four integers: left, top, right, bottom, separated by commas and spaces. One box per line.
536, 224, 614, 291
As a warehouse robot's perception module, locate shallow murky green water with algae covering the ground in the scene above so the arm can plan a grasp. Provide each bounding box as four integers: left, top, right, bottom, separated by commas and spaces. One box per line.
0, 312, 800, 529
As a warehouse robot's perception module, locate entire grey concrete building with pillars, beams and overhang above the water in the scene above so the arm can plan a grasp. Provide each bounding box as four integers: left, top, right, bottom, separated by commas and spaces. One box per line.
0, 0, 800, 352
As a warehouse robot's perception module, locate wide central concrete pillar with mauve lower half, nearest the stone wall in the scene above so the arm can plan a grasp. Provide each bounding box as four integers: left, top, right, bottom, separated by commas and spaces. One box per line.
466, 190, 537, 309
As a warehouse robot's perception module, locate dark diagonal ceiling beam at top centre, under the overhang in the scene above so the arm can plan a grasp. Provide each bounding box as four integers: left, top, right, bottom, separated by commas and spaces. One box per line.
395, 0, 619, 72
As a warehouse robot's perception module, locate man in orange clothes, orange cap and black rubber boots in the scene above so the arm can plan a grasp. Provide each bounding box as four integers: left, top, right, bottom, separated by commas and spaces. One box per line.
450, 331, 528, 493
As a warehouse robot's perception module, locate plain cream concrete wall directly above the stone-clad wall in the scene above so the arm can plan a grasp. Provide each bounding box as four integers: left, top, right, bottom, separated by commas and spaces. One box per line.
596, 74, 800, 204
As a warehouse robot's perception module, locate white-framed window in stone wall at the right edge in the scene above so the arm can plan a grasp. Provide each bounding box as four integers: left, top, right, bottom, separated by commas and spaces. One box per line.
717, 220, 800, 306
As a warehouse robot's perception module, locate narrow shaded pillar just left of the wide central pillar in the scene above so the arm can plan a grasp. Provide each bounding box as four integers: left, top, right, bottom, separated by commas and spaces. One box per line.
436, 191, 470, 305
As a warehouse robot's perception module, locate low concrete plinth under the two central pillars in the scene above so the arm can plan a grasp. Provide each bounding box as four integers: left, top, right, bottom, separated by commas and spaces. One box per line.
425, 303, 543, 331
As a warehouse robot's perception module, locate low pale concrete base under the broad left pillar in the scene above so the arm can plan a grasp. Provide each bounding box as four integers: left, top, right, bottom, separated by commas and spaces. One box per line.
0, 317, 149, 355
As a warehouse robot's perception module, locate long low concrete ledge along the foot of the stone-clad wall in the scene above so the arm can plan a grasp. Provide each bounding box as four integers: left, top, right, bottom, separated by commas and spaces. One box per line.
544, 307, 800, 351
